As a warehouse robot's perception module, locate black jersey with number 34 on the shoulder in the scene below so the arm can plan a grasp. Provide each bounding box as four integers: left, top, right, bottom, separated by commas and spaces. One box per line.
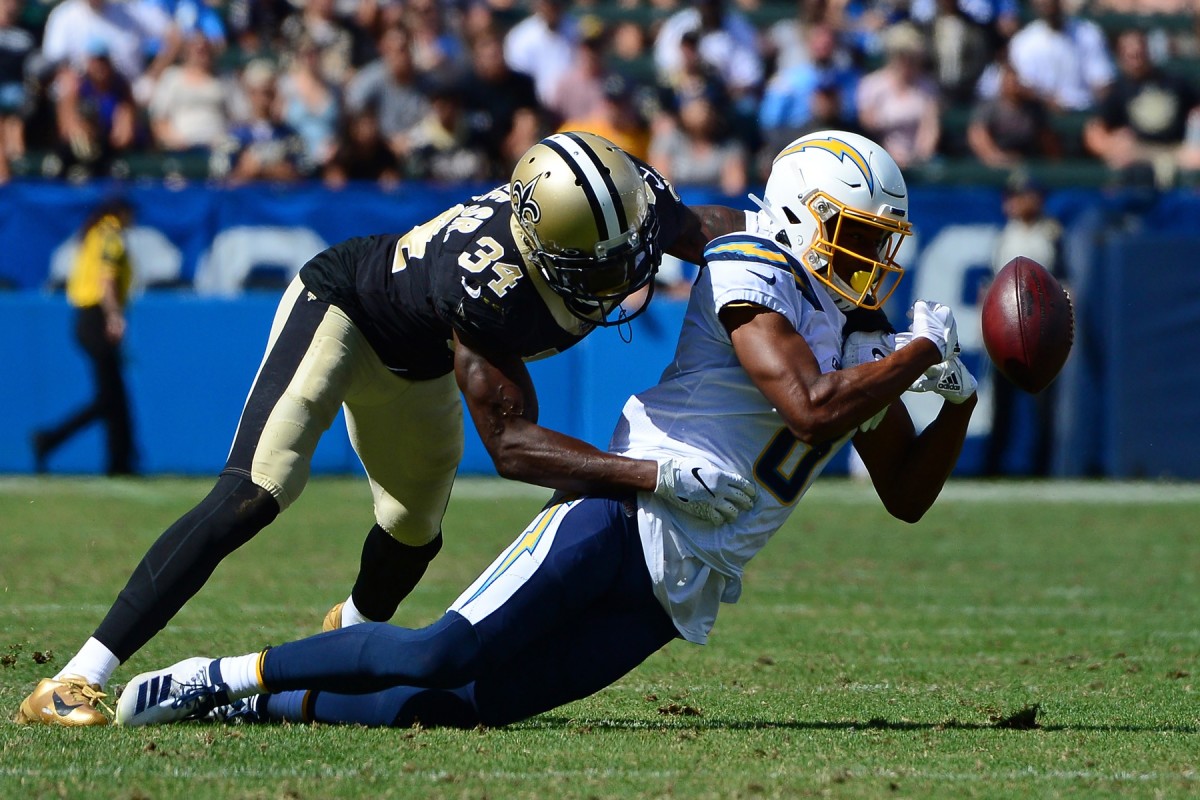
300, 162, 684, 380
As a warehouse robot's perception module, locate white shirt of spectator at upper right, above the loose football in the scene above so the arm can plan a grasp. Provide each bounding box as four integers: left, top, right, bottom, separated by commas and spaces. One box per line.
1008, 0, 1114, 112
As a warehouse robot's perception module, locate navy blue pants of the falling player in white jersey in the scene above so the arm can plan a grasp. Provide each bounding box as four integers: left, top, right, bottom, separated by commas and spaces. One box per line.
263, 498, 678, 727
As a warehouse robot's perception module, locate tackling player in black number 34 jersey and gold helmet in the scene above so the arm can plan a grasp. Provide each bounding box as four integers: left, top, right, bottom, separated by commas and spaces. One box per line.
17, 133, 754, 726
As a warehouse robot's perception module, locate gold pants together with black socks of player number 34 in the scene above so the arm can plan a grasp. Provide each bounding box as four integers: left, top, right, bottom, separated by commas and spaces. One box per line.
88, 279, 462, 662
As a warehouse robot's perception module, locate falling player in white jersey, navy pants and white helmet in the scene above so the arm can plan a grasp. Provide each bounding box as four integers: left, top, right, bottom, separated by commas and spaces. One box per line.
116, 131, 976, 726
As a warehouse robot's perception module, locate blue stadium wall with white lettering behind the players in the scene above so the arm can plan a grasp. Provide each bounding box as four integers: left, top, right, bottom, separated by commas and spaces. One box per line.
0, 182, 1200, 479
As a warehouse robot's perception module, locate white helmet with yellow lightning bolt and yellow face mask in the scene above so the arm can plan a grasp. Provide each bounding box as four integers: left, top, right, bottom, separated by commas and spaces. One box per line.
752, 131, 912, 309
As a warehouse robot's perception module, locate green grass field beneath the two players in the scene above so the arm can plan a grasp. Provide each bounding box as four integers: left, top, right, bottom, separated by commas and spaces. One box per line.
0, 479, 1200, 800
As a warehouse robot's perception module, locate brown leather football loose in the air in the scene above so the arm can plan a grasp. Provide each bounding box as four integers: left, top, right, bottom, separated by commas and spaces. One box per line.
980, 255, 1075, 395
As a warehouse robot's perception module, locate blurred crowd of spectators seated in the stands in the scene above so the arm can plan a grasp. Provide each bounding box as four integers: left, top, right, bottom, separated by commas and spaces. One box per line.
0, 0, 1200, 189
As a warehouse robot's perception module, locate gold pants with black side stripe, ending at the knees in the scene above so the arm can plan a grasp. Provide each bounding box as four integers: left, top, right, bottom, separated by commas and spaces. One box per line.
222, 278, 463, 546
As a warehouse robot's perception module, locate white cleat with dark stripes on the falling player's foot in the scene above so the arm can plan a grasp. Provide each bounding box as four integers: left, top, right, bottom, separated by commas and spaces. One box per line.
116, 658, 229, 727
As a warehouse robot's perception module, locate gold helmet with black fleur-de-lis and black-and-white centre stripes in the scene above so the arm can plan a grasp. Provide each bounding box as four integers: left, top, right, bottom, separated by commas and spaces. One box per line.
509, 132, 662, 325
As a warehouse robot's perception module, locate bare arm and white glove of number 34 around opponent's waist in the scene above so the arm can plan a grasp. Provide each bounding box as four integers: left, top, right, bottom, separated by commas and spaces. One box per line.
455, 335, 755, 523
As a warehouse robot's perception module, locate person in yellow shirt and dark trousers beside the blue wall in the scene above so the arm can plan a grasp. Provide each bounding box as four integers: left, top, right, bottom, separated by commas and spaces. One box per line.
34, 198, 134, 475
